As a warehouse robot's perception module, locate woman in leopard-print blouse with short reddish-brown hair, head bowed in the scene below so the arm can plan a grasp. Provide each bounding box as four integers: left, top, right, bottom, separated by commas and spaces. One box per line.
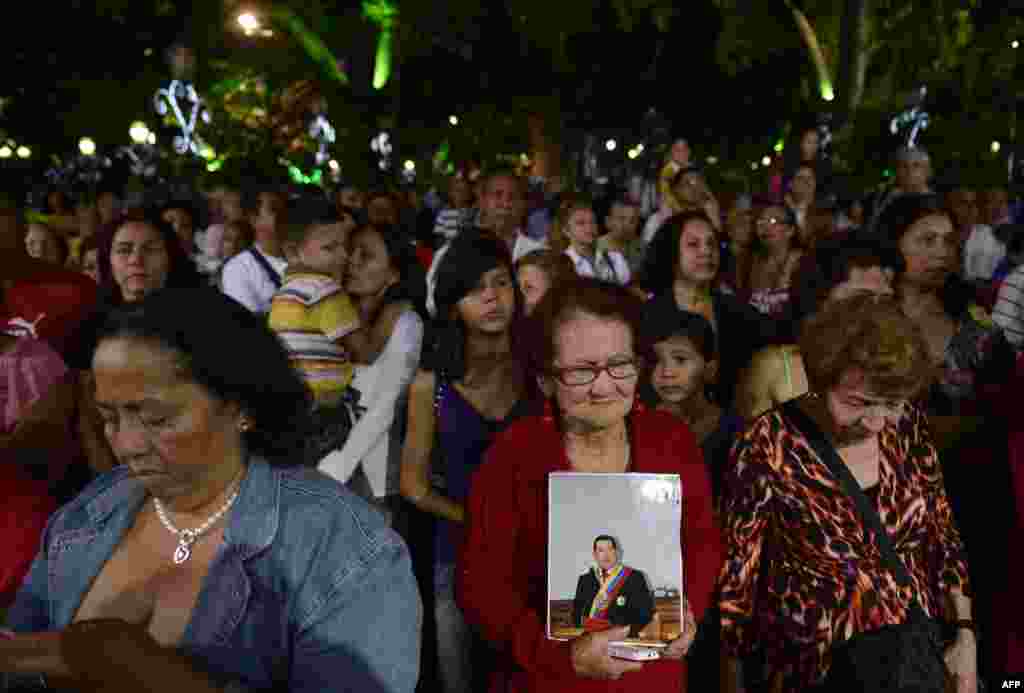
719, 296, 977, 691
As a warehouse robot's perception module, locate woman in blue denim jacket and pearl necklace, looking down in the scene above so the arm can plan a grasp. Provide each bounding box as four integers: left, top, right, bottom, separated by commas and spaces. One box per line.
0, 289, 422, 693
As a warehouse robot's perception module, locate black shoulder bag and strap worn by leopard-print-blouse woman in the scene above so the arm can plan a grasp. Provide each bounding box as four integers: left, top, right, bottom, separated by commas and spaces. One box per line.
781, 400, 952, 693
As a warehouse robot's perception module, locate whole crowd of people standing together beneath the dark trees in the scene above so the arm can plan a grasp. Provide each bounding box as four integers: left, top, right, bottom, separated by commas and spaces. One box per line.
0, 129, 1024, 693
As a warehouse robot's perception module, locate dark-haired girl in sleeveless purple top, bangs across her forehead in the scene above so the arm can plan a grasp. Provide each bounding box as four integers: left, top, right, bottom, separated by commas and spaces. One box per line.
401, 234, 537, 692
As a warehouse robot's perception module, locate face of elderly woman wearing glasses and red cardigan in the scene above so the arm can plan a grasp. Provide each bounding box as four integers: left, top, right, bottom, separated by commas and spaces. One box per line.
545, 313, 638, 432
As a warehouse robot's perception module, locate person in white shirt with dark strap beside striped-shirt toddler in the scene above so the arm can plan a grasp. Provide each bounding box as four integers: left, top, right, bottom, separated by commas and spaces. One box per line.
222, 185, 288, 315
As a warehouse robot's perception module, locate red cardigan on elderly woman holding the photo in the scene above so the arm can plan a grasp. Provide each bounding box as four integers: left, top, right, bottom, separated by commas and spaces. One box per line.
458, 412, 722, 693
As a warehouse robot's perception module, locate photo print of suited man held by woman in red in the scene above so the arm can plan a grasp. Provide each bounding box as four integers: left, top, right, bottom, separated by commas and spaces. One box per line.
548, 473, 684, 646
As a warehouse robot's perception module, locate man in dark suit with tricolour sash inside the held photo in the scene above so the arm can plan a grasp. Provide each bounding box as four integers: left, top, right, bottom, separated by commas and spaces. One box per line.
572, 534, 654, 638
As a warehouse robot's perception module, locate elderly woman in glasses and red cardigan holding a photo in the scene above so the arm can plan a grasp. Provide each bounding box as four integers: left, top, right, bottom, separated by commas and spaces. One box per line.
459, 280, 722, 693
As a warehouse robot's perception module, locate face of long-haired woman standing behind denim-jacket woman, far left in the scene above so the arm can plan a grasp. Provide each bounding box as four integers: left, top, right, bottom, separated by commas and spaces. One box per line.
111, 221, 171, 303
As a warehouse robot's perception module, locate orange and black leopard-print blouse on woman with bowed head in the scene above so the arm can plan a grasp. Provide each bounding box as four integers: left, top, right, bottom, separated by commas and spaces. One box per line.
719, 407, 971, 691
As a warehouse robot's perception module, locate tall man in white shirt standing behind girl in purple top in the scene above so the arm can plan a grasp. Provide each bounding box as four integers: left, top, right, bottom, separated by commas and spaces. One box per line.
427, 171, 548, 316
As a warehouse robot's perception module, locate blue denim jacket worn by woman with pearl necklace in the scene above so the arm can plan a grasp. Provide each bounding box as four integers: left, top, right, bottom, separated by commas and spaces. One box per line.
7, 459, 423, 693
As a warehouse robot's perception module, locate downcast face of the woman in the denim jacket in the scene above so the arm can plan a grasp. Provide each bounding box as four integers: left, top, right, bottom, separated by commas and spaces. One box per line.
92, 338, 242, 501
